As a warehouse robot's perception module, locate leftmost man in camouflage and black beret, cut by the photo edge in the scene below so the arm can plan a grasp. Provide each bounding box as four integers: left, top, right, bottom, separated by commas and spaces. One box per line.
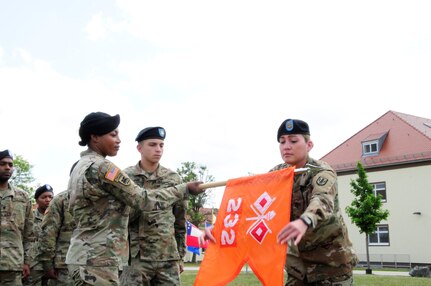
0, 150, 35, 286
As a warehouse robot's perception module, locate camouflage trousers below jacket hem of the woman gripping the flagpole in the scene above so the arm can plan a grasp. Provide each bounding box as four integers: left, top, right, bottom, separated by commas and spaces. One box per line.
68, 265, 120, 286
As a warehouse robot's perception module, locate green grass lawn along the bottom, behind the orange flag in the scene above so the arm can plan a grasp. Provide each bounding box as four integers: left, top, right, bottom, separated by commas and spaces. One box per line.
181, 271, 431, 286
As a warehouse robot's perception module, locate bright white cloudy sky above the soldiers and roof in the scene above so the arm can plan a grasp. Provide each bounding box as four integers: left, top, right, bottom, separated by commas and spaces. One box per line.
0, 0, 431, 207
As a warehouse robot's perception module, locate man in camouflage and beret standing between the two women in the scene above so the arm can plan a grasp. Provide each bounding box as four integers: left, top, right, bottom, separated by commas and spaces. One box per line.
120, 127, 187, 286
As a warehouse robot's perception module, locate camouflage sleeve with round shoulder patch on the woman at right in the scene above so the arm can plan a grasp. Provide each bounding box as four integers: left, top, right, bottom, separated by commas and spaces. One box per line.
304, 170, 337, 226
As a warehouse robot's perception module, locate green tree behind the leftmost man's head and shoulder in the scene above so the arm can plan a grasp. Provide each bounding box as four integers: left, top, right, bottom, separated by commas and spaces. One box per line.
10, 155, 35, 198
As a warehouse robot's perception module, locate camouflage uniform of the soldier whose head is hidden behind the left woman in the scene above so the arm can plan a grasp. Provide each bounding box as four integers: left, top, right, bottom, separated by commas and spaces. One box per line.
37, 191, 75, 286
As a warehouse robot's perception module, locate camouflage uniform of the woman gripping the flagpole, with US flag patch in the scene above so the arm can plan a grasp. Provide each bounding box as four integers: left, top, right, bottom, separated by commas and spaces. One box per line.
66, 149, 186, 286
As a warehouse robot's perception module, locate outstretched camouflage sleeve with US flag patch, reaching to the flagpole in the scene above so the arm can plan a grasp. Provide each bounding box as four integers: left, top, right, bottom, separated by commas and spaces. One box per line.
93, 161, 186, 210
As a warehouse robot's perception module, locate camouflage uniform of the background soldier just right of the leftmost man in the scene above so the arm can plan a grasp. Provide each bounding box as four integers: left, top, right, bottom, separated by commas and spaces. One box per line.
22, 208, 48, 286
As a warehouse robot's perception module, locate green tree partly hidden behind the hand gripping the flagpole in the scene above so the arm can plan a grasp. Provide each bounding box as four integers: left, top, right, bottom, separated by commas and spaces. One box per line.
177, 162, 214, 262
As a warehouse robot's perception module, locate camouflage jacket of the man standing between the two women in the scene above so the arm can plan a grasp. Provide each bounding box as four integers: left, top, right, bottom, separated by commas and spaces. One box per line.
124, 162, 187, 261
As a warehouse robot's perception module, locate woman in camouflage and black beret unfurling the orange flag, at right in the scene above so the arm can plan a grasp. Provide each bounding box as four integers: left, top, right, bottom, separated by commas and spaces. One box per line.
271, 119, 357, 286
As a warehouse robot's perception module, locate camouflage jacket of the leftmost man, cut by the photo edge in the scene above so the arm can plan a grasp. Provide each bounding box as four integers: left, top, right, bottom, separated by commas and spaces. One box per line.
0, 184, 35, 271
